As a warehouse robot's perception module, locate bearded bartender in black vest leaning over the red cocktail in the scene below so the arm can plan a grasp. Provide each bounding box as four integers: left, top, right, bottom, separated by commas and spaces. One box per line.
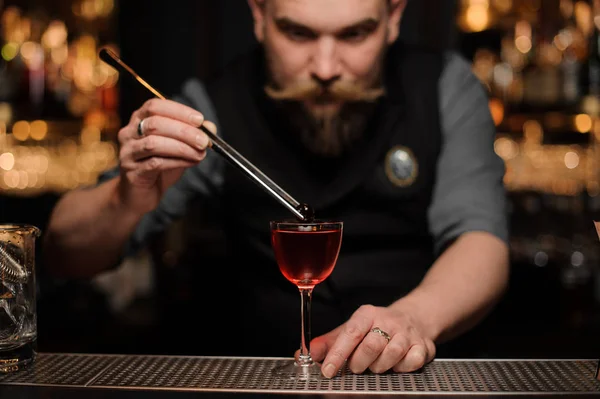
45, 0, 509, 377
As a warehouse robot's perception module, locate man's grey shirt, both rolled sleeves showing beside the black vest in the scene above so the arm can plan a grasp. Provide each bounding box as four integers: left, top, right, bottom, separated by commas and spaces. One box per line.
101, 52, 508, 253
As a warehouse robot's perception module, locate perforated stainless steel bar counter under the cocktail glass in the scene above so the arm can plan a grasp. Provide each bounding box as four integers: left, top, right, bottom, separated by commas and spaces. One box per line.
0, 353, 600, 399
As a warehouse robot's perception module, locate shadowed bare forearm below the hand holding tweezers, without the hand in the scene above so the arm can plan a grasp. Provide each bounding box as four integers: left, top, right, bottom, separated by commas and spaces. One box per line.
43, 177, 141, 277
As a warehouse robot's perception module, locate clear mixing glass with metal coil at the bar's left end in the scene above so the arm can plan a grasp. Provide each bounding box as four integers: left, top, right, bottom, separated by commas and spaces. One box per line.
0, 224, 40, 373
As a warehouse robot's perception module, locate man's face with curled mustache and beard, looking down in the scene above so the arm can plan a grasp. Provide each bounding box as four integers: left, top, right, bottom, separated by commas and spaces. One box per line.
250, 0, 404, 156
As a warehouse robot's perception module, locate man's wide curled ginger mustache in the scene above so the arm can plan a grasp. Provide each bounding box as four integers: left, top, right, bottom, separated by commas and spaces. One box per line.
265, 80, 385, 102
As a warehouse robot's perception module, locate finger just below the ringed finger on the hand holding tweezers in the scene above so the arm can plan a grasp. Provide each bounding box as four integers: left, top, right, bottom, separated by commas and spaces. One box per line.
130, 135, 206, 162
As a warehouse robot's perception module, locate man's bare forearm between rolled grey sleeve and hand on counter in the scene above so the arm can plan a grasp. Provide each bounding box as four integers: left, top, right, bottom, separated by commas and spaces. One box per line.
392, 232, 509, 343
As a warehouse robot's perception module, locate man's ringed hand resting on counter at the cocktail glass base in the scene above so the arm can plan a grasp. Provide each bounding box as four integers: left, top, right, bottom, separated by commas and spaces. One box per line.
311, 305, 435, 378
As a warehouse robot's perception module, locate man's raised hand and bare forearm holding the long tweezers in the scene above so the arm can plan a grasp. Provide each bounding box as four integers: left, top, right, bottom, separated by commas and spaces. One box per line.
44, 99, 216, 278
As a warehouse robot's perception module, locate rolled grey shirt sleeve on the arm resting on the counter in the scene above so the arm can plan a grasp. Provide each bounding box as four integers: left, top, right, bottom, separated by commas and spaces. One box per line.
428, 53, 508, 254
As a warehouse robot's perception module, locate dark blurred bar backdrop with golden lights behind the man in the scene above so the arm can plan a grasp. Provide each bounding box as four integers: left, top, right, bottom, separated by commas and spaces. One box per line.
0, 0, 600, 358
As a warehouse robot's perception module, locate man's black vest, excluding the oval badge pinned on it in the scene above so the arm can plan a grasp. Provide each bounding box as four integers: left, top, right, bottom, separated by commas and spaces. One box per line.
207, 43, 443, 354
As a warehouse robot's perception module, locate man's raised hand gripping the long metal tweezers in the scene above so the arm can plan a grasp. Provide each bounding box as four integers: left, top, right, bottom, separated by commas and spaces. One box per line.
119, 99, 216, 213
